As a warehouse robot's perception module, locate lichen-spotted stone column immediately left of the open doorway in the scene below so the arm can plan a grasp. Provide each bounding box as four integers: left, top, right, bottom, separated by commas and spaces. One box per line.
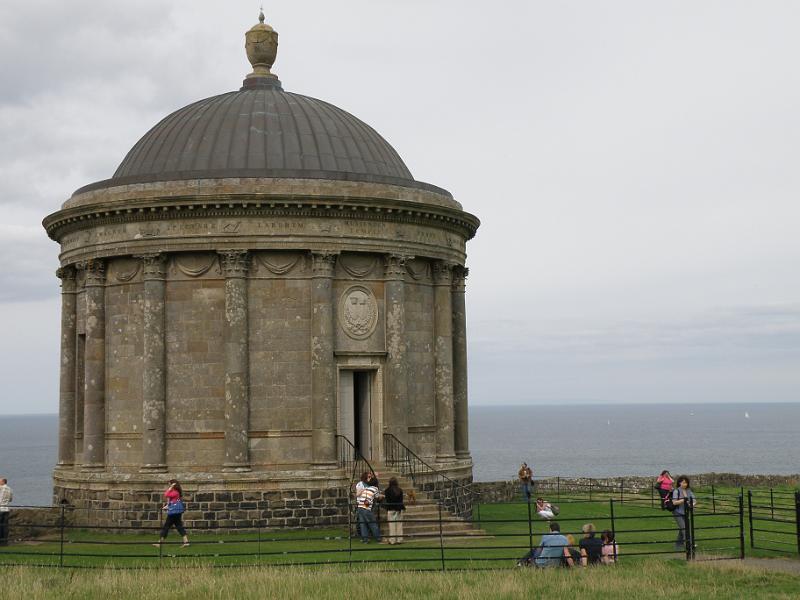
311, 252, 337, 468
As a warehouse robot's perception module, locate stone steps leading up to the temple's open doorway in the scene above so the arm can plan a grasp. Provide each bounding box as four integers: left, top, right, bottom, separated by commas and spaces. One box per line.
370, 468, 488, 542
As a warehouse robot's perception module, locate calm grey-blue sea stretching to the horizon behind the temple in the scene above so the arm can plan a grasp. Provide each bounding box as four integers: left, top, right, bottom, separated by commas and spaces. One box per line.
0, 403, 800, 506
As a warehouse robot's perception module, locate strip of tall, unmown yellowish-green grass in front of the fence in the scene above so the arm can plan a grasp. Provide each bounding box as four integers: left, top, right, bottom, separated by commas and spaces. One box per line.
0, 559, 800, 600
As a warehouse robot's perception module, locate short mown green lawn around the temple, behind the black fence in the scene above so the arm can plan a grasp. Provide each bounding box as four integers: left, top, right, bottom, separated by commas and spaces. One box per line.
0, 490, 797, 570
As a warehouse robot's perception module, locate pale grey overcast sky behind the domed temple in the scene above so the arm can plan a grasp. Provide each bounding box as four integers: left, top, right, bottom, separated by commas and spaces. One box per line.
0, 0, 800, 413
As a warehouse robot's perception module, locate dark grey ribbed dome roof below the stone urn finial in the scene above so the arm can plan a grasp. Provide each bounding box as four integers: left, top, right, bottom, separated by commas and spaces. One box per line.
112, 89, 414, 181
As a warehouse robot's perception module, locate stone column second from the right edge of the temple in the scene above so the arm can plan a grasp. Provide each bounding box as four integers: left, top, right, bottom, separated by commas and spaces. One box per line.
433, 261, 455, 461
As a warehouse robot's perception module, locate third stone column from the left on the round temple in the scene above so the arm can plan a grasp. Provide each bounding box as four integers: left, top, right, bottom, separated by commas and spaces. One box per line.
139, 253, 167, 472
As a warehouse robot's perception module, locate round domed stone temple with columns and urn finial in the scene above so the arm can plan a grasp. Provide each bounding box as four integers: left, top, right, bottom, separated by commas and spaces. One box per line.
44, 14, 479, 525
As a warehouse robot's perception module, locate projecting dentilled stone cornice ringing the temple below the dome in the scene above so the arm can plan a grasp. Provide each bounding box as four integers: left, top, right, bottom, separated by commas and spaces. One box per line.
43, 194, 480, 241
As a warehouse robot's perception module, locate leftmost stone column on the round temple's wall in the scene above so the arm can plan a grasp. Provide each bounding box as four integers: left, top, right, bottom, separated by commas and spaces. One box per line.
56, 265, 77, 467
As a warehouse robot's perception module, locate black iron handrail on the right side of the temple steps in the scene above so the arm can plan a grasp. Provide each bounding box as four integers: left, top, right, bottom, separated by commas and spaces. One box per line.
383, 433, 480, 519
